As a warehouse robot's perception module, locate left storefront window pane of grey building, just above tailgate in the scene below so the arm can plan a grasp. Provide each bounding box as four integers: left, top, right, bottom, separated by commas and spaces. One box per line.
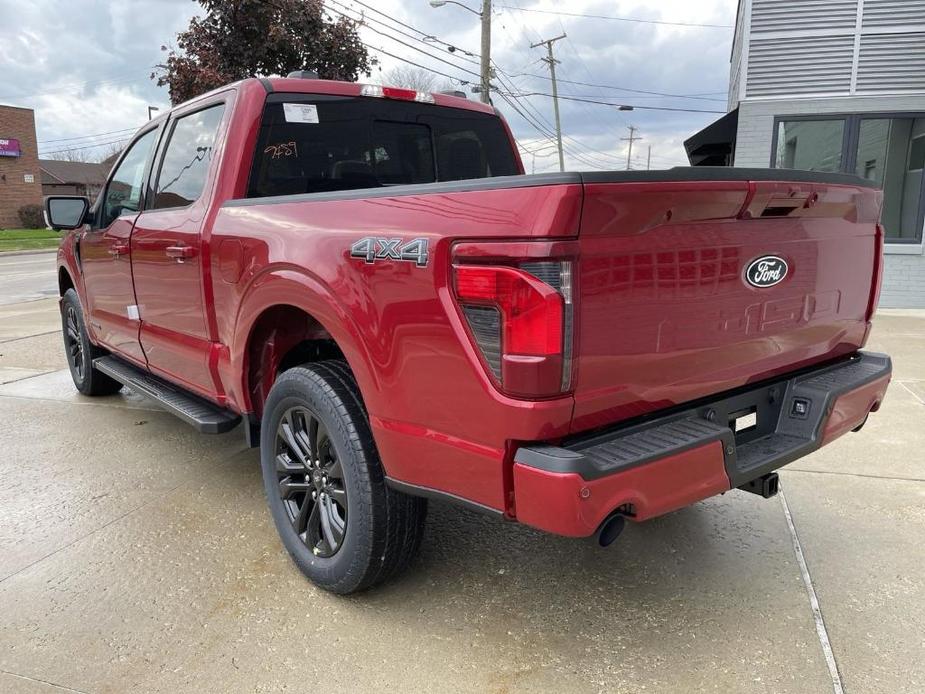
775, 120, 845, 172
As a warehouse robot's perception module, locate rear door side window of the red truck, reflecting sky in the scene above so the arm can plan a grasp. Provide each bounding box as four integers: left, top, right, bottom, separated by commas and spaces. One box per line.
149, 104, 225, 210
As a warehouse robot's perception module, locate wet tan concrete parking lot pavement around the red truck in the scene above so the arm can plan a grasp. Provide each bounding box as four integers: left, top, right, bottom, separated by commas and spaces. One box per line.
0, 254, 925, 693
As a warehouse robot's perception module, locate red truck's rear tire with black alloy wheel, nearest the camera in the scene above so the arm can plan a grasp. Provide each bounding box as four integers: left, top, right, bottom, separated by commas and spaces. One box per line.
260, 361, 427, 595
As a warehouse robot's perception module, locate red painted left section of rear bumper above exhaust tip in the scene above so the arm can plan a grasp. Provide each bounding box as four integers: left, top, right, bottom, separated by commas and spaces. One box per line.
514, 441, 729, 537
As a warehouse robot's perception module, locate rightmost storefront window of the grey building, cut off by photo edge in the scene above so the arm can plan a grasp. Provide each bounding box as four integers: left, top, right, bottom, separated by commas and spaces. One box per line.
855, 118, 925, 241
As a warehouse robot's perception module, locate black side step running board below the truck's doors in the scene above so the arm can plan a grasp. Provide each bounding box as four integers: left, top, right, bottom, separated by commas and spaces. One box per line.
93, 357, 241, 434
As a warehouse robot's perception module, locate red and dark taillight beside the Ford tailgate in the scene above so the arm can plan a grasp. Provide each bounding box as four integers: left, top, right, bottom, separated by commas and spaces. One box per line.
454, 260, 573, 397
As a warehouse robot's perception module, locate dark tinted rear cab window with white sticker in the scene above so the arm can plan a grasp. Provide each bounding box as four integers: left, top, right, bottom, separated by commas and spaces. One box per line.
247, 94, 519, 198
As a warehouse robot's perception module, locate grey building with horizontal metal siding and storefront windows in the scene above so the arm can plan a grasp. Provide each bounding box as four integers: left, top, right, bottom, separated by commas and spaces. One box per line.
685, 0, 925, 308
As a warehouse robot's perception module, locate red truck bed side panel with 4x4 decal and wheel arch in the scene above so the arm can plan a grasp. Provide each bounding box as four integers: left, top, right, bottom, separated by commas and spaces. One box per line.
212, 186, 581, 509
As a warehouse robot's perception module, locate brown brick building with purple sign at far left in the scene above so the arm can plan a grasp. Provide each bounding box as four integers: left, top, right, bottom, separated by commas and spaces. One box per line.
0, 106, 42, 229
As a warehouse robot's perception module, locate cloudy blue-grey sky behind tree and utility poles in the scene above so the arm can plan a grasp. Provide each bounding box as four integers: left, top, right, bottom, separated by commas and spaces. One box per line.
0, 0, 736, 172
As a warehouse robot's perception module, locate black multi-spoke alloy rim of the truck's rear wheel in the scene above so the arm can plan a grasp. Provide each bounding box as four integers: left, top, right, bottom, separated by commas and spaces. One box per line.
276, 407, 348, 557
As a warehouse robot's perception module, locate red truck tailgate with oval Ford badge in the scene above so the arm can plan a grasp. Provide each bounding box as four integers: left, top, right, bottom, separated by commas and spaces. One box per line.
572, 174, 882, 432
